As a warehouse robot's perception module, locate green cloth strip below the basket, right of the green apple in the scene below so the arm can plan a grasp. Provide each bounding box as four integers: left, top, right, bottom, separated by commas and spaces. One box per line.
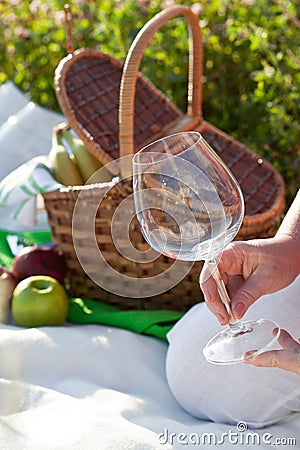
67, 298, 183, 341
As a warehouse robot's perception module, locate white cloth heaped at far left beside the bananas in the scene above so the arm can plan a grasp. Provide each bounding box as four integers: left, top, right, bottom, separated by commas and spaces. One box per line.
0, 81, 64, 231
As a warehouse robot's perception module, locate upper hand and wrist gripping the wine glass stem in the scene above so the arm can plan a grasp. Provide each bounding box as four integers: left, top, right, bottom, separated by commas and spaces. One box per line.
201, 191, 300, 325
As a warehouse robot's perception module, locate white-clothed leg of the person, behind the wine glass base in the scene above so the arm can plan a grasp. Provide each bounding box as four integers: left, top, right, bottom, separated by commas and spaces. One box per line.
166, 276, 300, 428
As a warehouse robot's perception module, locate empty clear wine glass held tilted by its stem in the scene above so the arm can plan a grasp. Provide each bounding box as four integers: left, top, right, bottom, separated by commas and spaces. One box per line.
132, 131, 279, 364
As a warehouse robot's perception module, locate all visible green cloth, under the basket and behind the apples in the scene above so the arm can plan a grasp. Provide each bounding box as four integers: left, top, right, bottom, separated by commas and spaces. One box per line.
0, 230, 183, 341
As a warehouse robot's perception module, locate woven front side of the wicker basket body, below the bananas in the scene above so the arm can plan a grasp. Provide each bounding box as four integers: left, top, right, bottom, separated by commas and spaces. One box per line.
46, 182, 202, 310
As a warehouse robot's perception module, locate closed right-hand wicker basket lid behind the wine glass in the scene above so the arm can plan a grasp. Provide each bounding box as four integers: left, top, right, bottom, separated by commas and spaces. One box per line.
197, 121, 285, 240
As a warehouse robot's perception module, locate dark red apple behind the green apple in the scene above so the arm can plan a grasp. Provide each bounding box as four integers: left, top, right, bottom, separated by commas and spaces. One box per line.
11, 246, 67, 284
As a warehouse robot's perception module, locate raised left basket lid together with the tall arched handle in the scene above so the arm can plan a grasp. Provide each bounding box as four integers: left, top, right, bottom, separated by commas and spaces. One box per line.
54, 5, 202, 174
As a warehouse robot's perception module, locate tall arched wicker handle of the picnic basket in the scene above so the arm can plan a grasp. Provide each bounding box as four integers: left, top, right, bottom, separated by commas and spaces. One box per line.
119, 5, 203, 178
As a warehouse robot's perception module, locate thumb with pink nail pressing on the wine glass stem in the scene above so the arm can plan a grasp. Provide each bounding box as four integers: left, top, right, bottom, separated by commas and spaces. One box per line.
231, 274, 266, 320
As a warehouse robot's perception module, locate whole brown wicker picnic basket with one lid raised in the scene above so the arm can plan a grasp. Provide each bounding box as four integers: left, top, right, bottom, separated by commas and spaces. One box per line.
44, 5, 285, 310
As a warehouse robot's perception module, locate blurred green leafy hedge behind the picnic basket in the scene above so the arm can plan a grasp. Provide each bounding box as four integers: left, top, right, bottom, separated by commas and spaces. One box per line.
0, 0, 300, 204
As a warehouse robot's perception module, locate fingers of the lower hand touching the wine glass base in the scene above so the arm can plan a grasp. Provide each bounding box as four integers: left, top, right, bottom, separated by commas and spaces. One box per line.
244, 349, 300, 375
